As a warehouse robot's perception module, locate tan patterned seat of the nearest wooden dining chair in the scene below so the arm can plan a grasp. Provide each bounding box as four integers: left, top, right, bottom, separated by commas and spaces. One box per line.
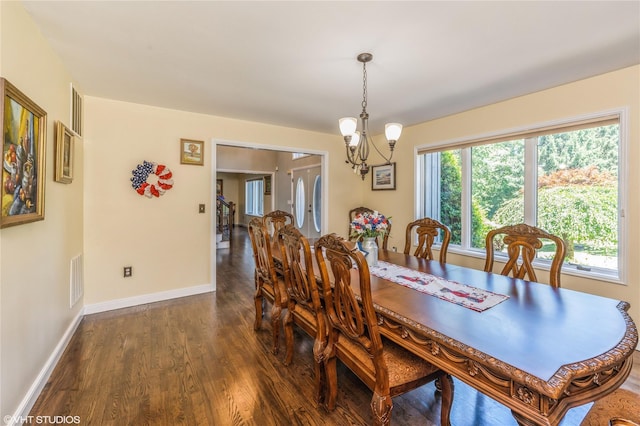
336, 336, 440, 396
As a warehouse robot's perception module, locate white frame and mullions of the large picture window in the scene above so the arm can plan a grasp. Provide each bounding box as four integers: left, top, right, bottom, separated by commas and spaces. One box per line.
414, 107, 629, 285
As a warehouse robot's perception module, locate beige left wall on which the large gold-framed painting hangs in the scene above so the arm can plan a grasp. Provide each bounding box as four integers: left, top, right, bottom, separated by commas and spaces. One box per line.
0, 1, 84, 415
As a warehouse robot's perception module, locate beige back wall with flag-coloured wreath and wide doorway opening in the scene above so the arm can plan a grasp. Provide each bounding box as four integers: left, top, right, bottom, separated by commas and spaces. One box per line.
84, 96, 352, 305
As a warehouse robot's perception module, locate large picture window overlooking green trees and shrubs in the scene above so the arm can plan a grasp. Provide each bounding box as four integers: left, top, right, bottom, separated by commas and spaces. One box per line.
417, 113, 624, 279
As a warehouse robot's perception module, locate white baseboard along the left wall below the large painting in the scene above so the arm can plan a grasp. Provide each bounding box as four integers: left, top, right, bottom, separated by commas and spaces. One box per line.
9, 309, 84, 426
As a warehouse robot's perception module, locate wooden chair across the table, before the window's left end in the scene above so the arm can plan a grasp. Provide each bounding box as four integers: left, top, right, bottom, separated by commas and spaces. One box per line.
404, 217, 451, 263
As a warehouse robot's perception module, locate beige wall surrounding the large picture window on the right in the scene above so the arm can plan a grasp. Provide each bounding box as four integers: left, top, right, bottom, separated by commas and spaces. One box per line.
364, 66, 640, 324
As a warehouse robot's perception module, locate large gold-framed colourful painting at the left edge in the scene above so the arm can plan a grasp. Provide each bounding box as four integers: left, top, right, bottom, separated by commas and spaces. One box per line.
0, 78, 47, 228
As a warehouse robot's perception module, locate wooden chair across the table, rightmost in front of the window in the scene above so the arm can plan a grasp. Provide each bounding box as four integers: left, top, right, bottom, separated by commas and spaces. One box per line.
484, 223, 566, 287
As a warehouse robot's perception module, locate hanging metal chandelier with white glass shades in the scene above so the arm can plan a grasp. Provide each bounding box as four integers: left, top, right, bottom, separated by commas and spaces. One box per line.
338, 53, 402, 180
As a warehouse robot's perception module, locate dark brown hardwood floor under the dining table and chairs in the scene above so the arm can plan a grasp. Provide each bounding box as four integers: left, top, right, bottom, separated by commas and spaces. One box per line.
30, 228, 640, 426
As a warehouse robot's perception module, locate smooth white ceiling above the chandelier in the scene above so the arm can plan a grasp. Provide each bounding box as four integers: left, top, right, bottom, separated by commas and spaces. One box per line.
23, 0, 640, 133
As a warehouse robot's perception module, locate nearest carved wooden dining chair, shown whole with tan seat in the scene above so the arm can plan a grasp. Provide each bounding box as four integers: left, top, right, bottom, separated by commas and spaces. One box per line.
315, 234, 453, 425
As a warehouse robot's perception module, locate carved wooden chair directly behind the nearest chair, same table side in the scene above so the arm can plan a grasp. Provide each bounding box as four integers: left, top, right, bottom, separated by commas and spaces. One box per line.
278, 224, 327, 404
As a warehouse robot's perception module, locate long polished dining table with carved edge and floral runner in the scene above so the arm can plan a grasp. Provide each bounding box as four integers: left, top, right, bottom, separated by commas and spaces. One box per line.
364, 249, 638, 425
